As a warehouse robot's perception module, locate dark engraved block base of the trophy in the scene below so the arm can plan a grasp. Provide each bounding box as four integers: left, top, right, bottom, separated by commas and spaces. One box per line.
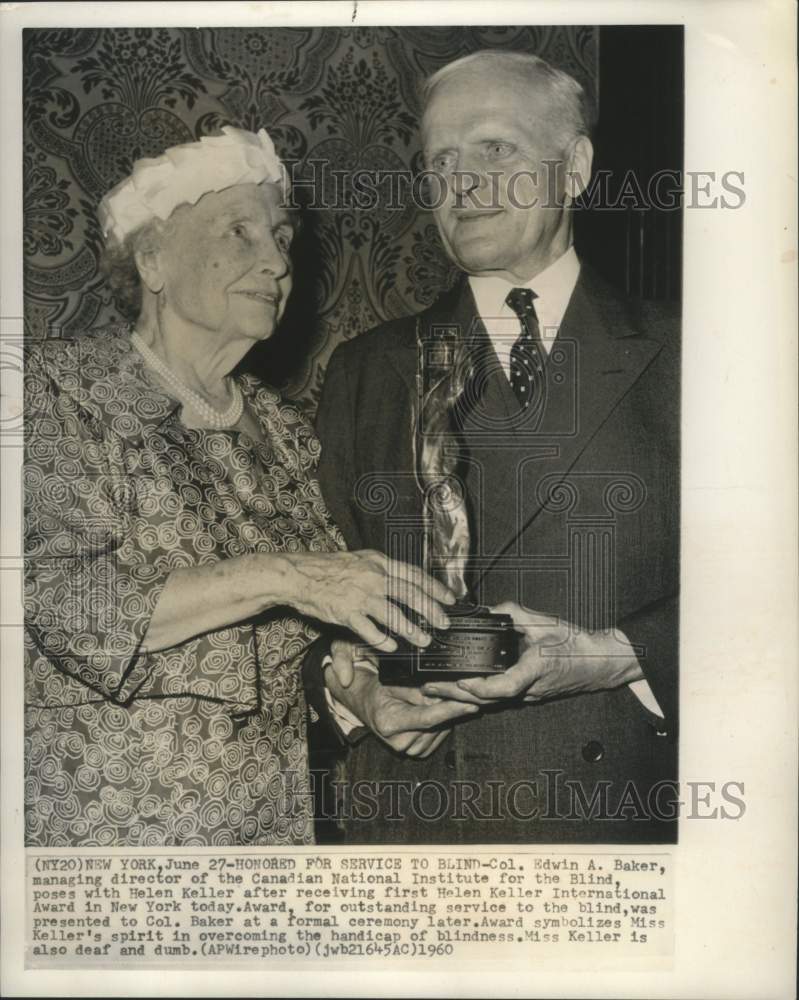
379, 605, 519, 686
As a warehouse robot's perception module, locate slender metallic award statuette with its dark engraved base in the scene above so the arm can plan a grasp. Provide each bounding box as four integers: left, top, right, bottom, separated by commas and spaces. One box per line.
380, 327, 519, 685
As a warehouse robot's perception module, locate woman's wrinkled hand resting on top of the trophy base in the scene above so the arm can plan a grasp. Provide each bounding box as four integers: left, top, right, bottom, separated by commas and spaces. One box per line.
285, 550, 455, 653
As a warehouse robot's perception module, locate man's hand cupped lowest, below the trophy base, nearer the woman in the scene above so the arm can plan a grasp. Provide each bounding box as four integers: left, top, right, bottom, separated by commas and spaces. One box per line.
325, 640, 479, 757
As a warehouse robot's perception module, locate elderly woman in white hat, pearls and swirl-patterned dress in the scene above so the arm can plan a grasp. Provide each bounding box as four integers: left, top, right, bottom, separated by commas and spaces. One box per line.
25, 128, 458, 847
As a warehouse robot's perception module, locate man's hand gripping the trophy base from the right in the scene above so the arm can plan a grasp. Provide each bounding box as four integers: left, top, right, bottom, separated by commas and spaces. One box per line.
422, 602, 643, 705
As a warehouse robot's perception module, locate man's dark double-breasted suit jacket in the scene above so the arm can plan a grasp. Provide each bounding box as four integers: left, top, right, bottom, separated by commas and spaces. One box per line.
310, 267, 679, 844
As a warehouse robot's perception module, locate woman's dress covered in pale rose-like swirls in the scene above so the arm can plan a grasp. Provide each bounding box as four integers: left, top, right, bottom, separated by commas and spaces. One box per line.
25, 327, 344, 847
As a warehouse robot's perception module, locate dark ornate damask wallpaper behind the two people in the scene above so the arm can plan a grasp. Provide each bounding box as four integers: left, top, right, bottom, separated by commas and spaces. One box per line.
23, 26, 598, 409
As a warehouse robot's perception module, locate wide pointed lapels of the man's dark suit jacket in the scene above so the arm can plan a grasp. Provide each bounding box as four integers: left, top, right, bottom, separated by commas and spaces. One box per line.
388, 274, 662, 575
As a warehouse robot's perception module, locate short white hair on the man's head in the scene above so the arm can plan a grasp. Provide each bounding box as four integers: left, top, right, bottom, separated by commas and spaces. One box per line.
422, 49, 594, 154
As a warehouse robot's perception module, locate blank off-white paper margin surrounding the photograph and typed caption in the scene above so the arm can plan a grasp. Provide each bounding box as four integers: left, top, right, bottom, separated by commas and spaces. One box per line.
0, 0, 797, 1000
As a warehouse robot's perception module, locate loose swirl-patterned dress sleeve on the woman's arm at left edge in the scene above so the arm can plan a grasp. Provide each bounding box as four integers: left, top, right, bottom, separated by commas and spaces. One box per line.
24, 351, 169, 704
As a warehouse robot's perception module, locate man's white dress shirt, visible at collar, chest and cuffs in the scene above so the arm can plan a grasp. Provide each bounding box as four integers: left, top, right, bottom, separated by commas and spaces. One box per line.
323, 246, 663, 734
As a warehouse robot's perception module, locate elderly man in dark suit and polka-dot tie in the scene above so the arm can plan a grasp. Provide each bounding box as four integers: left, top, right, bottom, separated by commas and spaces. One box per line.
310, 51, 679, 844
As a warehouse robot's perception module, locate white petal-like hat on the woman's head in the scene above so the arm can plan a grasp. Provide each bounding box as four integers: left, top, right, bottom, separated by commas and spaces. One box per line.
97, 125, 288, 243
